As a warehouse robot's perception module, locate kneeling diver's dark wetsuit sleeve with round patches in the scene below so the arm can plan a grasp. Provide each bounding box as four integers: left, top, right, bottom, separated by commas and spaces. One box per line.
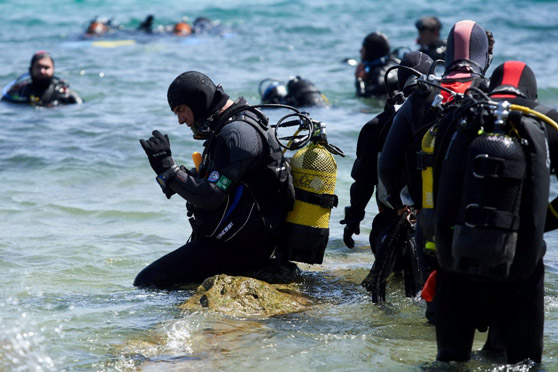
169, 122, 262, 211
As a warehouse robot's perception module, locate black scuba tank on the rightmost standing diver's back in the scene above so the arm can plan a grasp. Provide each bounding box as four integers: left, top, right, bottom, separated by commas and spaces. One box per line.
451, 133, 526, 279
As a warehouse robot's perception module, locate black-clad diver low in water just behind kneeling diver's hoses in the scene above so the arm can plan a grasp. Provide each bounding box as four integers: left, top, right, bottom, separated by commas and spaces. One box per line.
259, 76, 329, 107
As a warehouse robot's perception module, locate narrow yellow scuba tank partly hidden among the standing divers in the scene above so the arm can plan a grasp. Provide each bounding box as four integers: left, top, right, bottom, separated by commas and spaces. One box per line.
419, 125, 438, 255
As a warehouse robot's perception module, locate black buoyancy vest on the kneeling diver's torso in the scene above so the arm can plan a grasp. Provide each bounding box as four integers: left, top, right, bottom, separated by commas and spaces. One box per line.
187, 101, 294, 243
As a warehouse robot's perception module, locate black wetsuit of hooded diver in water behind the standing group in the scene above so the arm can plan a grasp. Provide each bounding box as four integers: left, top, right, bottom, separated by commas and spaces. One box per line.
355, 56, 399, 98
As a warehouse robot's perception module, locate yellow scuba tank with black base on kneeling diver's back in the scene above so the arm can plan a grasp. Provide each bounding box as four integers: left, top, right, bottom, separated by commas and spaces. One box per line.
276, 108, 344, 264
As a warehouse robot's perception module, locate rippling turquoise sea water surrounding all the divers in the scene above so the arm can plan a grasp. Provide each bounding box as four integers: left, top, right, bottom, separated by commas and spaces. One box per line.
0, 0, 558, 371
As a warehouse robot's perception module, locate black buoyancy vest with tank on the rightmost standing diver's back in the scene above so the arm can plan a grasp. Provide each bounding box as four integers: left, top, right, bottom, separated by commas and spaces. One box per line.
434, 95, 550, 280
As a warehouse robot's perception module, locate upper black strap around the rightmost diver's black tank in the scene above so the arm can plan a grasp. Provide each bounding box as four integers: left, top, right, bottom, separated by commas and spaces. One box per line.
473, 154, 527, 180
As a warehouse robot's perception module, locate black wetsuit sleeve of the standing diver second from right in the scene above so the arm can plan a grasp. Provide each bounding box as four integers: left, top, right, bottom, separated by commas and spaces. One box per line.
378, 100, 413, 209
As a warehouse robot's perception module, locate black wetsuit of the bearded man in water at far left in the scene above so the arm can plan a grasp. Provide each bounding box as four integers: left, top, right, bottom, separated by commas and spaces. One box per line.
2, 76, 83, 106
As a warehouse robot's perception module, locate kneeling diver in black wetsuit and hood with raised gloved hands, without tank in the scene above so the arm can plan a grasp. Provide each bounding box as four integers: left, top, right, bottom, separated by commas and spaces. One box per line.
134, 71, 294, 288
